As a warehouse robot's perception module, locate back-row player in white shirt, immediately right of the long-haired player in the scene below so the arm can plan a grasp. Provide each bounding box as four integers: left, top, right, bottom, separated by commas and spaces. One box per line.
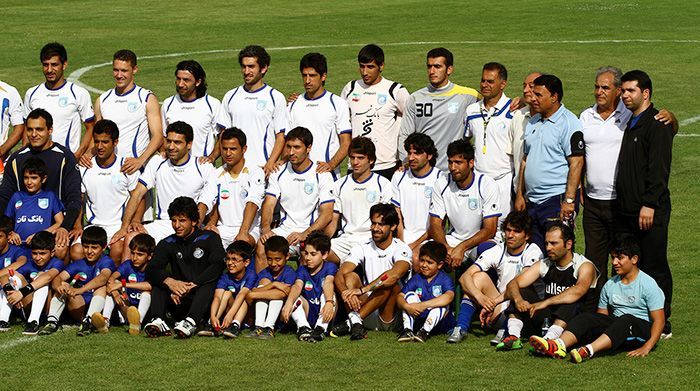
216, 45, 288, 175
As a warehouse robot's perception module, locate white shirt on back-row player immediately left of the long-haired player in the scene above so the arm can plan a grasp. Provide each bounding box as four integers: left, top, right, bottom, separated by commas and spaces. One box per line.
99, 84, 152, 157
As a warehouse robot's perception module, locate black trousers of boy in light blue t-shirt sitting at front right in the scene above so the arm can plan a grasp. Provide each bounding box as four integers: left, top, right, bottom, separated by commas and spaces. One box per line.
566, 313, 651, 350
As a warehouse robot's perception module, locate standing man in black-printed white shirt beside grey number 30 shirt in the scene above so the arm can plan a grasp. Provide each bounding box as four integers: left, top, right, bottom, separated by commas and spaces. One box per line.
340, 44, 409, 179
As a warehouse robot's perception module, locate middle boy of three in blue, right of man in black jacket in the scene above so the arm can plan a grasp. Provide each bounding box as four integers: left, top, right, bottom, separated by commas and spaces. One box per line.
245, 236, 296, 339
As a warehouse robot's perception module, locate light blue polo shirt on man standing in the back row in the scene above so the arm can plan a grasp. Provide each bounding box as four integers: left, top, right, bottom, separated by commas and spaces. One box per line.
523, 104, 584, 204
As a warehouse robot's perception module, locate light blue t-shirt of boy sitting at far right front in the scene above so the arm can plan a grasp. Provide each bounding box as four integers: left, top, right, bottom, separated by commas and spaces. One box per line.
598, 270, 664, 322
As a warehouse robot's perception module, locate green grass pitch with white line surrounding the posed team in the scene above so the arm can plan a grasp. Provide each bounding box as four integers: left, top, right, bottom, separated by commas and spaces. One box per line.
0, 0, 700, 389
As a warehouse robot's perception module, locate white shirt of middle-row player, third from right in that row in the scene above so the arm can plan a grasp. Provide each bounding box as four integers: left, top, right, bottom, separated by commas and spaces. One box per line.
333, 172, 392, 237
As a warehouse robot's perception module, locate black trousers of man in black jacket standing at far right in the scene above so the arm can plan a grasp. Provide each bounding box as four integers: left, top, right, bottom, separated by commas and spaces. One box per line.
616, 207, 673, 319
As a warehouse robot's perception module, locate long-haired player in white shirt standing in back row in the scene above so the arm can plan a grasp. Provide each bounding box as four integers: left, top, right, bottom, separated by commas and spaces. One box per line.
161, 60, 221, 163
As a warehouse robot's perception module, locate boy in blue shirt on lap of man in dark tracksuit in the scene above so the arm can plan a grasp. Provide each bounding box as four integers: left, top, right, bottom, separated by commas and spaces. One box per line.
5, 157, 63, 245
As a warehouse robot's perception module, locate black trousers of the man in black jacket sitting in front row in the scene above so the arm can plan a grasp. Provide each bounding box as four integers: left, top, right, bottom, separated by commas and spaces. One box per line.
150, 282, 216, 324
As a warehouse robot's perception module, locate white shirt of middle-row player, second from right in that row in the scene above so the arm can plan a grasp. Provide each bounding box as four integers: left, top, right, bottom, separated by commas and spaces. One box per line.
391, 167, 444, 244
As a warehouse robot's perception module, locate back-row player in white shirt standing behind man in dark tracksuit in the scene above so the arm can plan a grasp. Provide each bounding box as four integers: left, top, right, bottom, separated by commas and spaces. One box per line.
24, 42, 95, 159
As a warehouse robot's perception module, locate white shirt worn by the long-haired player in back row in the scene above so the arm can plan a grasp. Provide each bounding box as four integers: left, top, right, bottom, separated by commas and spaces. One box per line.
160, 94, 221, 156
